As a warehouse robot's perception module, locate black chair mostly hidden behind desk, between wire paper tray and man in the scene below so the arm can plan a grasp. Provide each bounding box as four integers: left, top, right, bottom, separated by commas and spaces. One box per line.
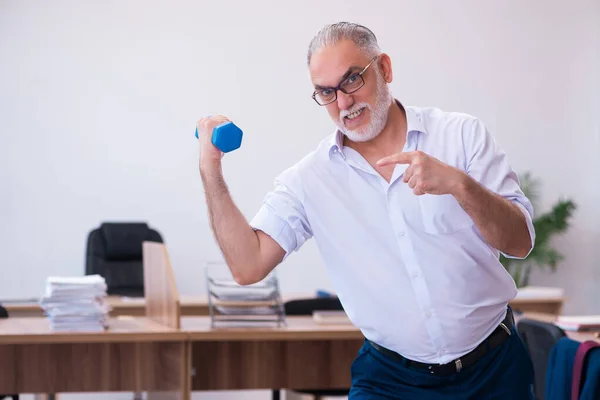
272, 297, 350, 400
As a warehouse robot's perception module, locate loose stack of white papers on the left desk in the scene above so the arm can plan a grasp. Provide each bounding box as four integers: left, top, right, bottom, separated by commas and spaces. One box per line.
40, 275, 110, 332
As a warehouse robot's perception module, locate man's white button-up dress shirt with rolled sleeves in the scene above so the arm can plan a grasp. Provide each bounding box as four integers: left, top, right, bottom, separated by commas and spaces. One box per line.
250, 103, 535, 363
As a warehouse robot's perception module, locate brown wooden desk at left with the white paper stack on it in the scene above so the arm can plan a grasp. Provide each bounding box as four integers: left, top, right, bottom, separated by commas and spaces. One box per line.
0, 318, 188, 398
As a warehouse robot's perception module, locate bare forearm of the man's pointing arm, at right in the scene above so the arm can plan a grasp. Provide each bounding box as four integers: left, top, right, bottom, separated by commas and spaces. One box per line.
452, 174, 532, 257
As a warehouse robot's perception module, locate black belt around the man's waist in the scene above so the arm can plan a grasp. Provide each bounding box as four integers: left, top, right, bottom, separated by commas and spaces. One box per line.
369, 307, 515, 375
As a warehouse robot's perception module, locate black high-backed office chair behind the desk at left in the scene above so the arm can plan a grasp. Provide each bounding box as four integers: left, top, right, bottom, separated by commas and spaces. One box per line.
85, 222, 163, 297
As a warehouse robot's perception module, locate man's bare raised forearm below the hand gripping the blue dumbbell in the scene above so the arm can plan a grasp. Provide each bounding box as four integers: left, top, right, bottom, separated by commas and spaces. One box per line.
200, 166, 260, 282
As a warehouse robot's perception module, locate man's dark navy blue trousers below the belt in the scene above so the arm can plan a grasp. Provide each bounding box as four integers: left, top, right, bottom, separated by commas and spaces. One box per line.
348, 329, 534, 400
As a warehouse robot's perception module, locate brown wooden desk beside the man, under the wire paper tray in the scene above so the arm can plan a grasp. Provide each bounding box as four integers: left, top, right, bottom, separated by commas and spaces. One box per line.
181, 317, 364, 391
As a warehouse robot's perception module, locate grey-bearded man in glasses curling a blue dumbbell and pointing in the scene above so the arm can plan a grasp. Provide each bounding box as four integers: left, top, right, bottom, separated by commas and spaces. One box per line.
198, 23, 535, 399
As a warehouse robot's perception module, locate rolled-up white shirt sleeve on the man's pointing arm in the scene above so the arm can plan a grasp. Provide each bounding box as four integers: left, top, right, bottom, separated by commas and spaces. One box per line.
464, 119, 535, 259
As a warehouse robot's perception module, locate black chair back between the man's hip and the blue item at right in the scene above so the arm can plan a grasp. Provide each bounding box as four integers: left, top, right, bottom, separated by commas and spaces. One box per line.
517, 318, 566, 400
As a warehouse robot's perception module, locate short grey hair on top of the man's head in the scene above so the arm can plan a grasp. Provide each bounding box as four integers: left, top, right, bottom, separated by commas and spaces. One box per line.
306, 22, 381, 65
